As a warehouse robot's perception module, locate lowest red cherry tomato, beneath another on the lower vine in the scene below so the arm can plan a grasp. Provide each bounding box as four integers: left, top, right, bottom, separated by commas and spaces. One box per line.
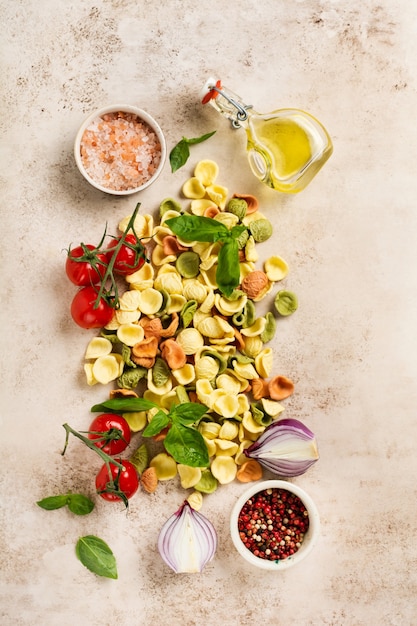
96, 459, 139, 502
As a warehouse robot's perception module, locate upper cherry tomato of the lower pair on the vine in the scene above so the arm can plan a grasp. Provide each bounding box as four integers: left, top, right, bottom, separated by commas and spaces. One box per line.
88, 413, 131, 455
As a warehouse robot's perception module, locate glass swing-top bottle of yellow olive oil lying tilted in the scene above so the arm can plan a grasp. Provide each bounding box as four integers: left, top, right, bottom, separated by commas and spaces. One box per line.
201, 79, 333, 193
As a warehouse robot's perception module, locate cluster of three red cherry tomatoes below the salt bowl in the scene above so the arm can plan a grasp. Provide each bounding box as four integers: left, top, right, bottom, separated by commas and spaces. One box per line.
65, 234, 146, 329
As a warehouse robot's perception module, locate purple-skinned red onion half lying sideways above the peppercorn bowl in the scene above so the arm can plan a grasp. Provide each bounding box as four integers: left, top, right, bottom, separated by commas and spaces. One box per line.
244, 418, 319, 478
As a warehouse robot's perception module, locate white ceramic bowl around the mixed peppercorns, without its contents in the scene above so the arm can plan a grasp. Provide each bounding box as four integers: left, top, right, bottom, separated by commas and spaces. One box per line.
230, 480, 320, 572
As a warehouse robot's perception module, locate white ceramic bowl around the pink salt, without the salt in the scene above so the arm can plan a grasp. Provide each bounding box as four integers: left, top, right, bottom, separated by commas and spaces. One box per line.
74, 104, 166, 196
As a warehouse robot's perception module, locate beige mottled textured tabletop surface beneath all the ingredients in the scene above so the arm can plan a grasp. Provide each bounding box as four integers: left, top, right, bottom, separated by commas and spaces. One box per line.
0, 0, 417, 626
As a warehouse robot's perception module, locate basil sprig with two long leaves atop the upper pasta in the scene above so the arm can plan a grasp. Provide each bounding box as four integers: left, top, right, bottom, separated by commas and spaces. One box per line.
166, 215, 246, 296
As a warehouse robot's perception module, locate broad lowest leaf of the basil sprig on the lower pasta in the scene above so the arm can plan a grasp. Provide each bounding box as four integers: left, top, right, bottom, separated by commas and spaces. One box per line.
164, 424, 210, 467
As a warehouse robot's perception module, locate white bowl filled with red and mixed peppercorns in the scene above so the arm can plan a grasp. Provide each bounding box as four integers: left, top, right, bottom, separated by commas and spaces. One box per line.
230, 480, 320, 571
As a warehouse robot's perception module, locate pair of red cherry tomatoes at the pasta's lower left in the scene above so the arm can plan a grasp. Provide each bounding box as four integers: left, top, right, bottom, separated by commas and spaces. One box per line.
88, 413, 139, 502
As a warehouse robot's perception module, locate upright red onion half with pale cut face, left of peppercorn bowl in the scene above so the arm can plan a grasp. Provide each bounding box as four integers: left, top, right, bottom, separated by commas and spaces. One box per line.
158, 500, 217, 574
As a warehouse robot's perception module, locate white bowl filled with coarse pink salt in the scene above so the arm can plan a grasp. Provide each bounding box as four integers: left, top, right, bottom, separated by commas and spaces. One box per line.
74, 104, 166, 196
